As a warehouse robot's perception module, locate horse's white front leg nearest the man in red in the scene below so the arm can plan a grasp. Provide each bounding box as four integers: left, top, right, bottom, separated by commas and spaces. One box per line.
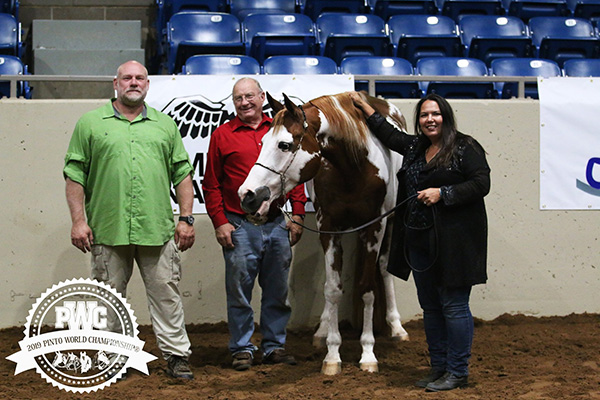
313, 235, 342, 375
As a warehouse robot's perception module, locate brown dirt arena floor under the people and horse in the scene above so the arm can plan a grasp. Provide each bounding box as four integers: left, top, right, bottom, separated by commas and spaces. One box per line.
0, 314, 600, 400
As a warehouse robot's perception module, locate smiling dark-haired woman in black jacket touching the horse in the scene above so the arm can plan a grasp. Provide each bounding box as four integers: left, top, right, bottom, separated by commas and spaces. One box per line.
350, 92, 490, 391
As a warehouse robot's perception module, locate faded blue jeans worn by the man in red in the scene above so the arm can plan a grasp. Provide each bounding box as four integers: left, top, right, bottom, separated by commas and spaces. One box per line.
223, 213, 292, 355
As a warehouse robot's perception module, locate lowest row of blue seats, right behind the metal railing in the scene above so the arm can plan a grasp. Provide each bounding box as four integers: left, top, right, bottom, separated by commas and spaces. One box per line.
182, 55, 600, 99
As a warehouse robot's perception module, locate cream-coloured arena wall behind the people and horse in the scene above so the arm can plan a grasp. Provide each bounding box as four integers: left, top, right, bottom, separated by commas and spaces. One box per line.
0, 99, 600, 328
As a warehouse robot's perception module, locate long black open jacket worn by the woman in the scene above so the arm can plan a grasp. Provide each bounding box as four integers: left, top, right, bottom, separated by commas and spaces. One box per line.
368, 113, 490, 287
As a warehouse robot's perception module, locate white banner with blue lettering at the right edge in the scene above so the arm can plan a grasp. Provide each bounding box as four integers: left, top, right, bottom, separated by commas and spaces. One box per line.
538, 77, 600, 210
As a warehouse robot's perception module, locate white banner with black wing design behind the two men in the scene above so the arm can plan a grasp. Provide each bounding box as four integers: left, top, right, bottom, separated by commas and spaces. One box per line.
146, 75, 354, 214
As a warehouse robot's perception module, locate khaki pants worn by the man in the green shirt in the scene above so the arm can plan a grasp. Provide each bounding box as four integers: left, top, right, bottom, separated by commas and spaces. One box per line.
92, 239, 191, 359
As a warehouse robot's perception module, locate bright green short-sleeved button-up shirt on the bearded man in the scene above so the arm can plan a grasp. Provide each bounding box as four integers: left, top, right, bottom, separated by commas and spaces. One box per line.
63, 99, 193, 246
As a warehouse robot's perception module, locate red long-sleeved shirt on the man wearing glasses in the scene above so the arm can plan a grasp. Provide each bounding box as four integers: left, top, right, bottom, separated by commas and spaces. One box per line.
202, 114, 306, 228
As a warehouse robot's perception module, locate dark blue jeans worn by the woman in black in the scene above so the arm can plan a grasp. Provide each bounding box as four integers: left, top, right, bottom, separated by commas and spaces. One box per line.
410, 251, 473, 376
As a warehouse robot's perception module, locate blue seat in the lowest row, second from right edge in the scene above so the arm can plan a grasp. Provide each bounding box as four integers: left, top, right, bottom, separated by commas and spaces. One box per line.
490, 58, 561, 99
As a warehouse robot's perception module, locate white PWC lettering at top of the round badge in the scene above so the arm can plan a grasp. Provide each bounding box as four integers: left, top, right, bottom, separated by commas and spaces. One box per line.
54, 301, 108, 330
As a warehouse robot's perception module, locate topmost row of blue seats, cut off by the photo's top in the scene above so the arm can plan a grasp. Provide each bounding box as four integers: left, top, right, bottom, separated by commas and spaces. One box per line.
156, 0, 600, 30
